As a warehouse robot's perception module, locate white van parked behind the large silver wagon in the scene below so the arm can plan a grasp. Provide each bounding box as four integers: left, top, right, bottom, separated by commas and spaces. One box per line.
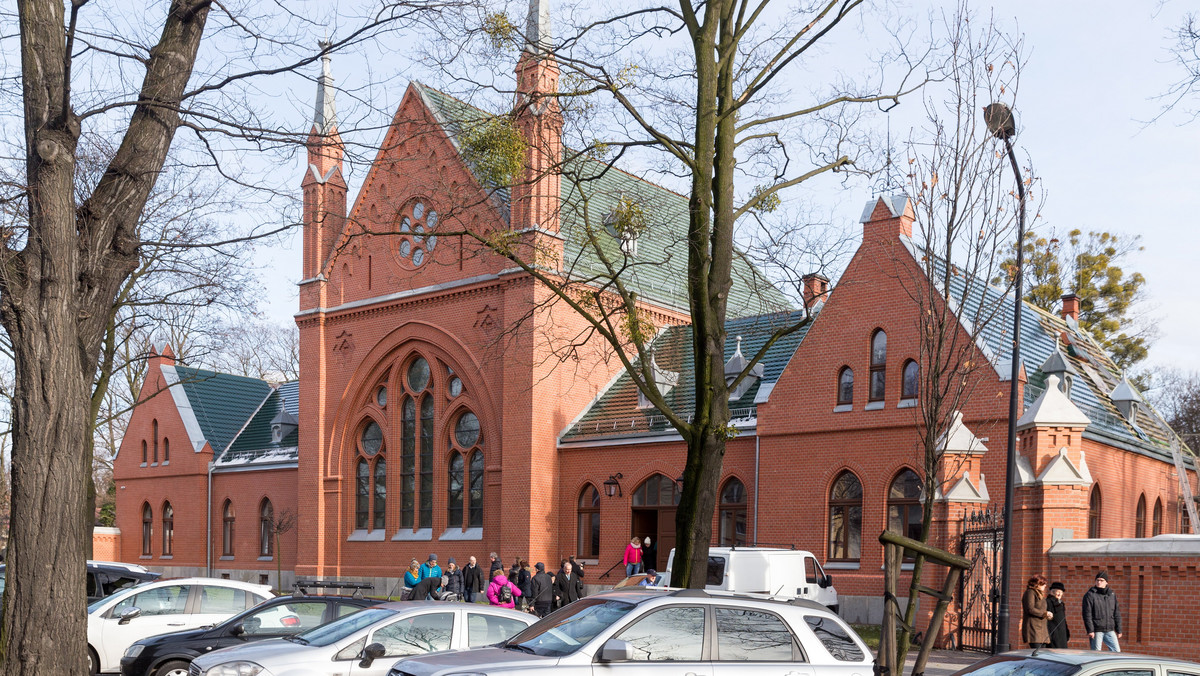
660, 546, 838, 612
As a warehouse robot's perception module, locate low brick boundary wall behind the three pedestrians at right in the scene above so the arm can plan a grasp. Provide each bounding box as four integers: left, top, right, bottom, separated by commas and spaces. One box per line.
1046, 536, 1200, 662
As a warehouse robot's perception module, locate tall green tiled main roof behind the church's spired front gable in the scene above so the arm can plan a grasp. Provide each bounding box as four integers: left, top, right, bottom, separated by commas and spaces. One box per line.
414, 84, 792, 317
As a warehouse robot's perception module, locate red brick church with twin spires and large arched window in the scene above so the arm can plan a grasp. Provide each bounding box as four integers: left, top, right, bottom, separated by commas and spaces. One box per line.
113, 0, 1194, 657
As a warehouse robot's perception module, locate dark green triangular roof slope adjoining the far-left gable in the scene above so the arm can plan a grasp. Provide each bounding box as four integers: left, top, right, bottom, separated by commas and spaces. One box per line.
175, 366, 271, 454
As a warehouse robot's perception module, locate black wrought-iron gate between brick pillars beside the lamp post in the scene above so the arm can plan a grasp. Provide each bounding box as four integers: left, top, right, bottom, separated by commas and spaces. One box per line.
959, 510, 1004, 653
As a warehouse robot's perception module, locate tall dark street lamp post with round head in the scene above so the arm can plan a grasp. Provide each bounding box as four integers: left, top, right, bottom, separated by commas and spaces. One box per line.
983, 103, 1025, 652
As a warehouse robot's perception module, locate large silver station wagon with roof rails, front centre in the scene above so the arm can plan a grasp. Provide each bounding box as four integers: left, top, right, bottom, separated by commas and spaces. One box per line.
389, 587, 872, 676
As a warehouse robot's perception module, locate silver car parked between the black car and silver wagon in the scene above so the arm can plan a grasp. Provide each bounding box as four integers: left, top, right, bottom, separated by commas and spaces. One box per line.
188, 600, 538, 676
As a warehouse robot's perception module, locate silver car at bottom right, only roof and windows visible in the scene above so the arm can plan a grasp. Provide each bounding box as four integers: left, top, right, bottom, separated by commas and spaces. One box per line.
954, 650, 1200, 676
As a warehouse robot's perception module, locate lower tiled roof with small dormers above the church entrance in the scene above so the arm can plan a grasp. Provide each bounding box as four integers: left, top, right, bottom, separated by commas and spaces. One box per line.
562, 312, 812, 442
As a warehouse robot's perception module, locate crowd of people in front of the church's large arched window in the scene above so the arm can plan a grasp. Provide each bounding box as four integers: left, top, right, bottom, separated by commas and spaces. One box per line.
403, 551, 583, 617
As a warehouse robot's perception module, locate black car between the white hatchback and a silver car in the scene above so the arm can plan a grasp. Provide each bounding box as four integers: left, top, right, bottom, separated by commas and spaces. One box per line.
121, 596, 383, 676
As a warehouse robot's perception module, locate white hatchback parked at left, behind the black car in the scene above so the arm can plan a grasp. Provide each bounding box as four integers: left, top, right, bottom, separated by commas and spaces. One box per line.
88, 578, 275, 674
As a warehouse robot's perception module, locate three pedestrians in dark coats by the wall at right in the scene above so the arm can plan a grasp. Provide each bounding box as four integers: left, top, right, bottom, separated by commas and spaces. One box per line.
1021, 570, 1122, 652
